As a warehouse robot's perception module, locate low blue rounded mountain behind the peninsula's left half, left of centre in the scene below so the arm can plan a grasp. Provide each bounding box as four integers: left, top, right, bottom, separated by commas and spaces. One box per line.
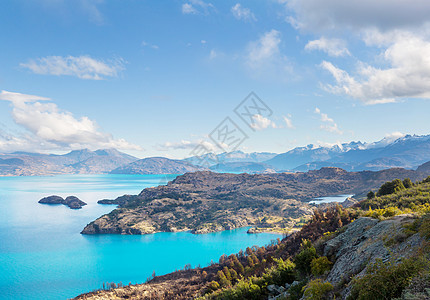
110, 157, 204, 174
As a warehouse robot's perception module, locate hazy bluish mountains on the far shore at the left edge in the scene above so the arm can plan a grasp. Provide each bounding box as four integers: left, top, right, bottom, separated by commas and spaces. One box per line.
0, 149, 138, 176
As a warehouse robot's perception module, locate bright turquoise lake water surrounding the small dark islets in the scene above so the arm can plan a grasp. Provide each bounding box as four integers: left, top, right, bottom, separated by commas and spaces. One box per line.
0, 175, 281, 300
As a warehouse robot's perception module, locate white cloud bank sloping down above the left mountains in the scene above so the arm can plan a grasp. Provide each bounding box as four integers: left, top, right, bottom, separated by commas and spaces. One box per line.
0, 91, 141, 150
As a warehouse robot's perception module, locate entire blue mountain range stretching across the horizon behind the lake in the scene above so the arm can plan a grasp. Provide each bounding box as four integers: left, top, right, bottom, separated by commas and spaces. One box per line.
0, 135, 430, 176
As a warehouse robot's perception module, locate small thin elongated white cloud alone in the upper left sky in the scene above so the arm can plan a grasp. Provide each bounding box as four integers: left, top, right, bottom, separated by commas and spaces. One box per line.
20, 55, 124, 80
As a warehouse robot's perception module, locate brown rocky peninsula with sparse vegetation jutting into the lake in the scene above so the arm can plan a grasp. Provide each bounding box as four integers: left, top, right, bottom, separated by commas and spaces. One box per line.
82, 168, 423, 234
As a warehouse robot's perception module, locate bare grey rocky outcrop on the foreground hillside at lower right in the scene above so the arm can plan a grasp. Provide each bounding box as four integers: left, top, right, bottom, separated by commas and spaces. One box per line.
324, 215, 423, 299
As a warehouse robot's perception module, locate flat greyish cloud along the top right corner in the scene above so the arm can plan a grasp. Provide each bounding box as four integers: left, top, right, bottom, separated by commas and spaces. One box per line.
281, 0, 430, 33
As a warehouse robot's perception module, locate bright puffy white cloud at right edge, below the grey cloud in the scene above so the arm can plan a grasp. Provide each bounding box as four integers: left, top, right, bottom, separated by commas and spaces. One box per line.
321, 32, 430, 104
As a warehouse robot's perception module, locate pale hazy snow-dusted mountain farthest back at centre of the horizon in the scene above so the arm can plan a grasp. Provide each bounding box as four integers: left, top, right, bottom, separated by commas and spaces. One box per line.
184, 150, 276, 166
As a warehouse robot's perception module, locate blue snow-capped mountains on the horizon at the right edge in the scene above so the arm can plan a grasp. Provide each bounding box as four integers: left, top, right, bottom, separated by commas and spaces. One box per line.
264, 135, 430, 171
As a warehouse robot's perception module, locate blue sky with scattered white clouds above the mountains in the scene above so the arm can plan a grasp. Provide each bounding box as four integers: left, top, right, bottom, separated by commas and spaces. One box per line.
0, 0, 430, 158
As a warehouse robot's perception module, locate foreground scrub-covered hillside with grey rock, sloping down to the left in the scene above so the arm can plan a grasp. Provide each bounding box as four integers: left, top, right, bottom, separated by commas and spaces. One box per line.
77, 177, 430, 300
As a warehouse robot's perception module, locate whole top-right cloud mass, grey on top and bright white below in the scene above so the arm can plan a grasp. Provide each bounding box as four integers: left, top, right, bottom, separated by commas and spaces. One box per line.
280, 0, 430, 104
